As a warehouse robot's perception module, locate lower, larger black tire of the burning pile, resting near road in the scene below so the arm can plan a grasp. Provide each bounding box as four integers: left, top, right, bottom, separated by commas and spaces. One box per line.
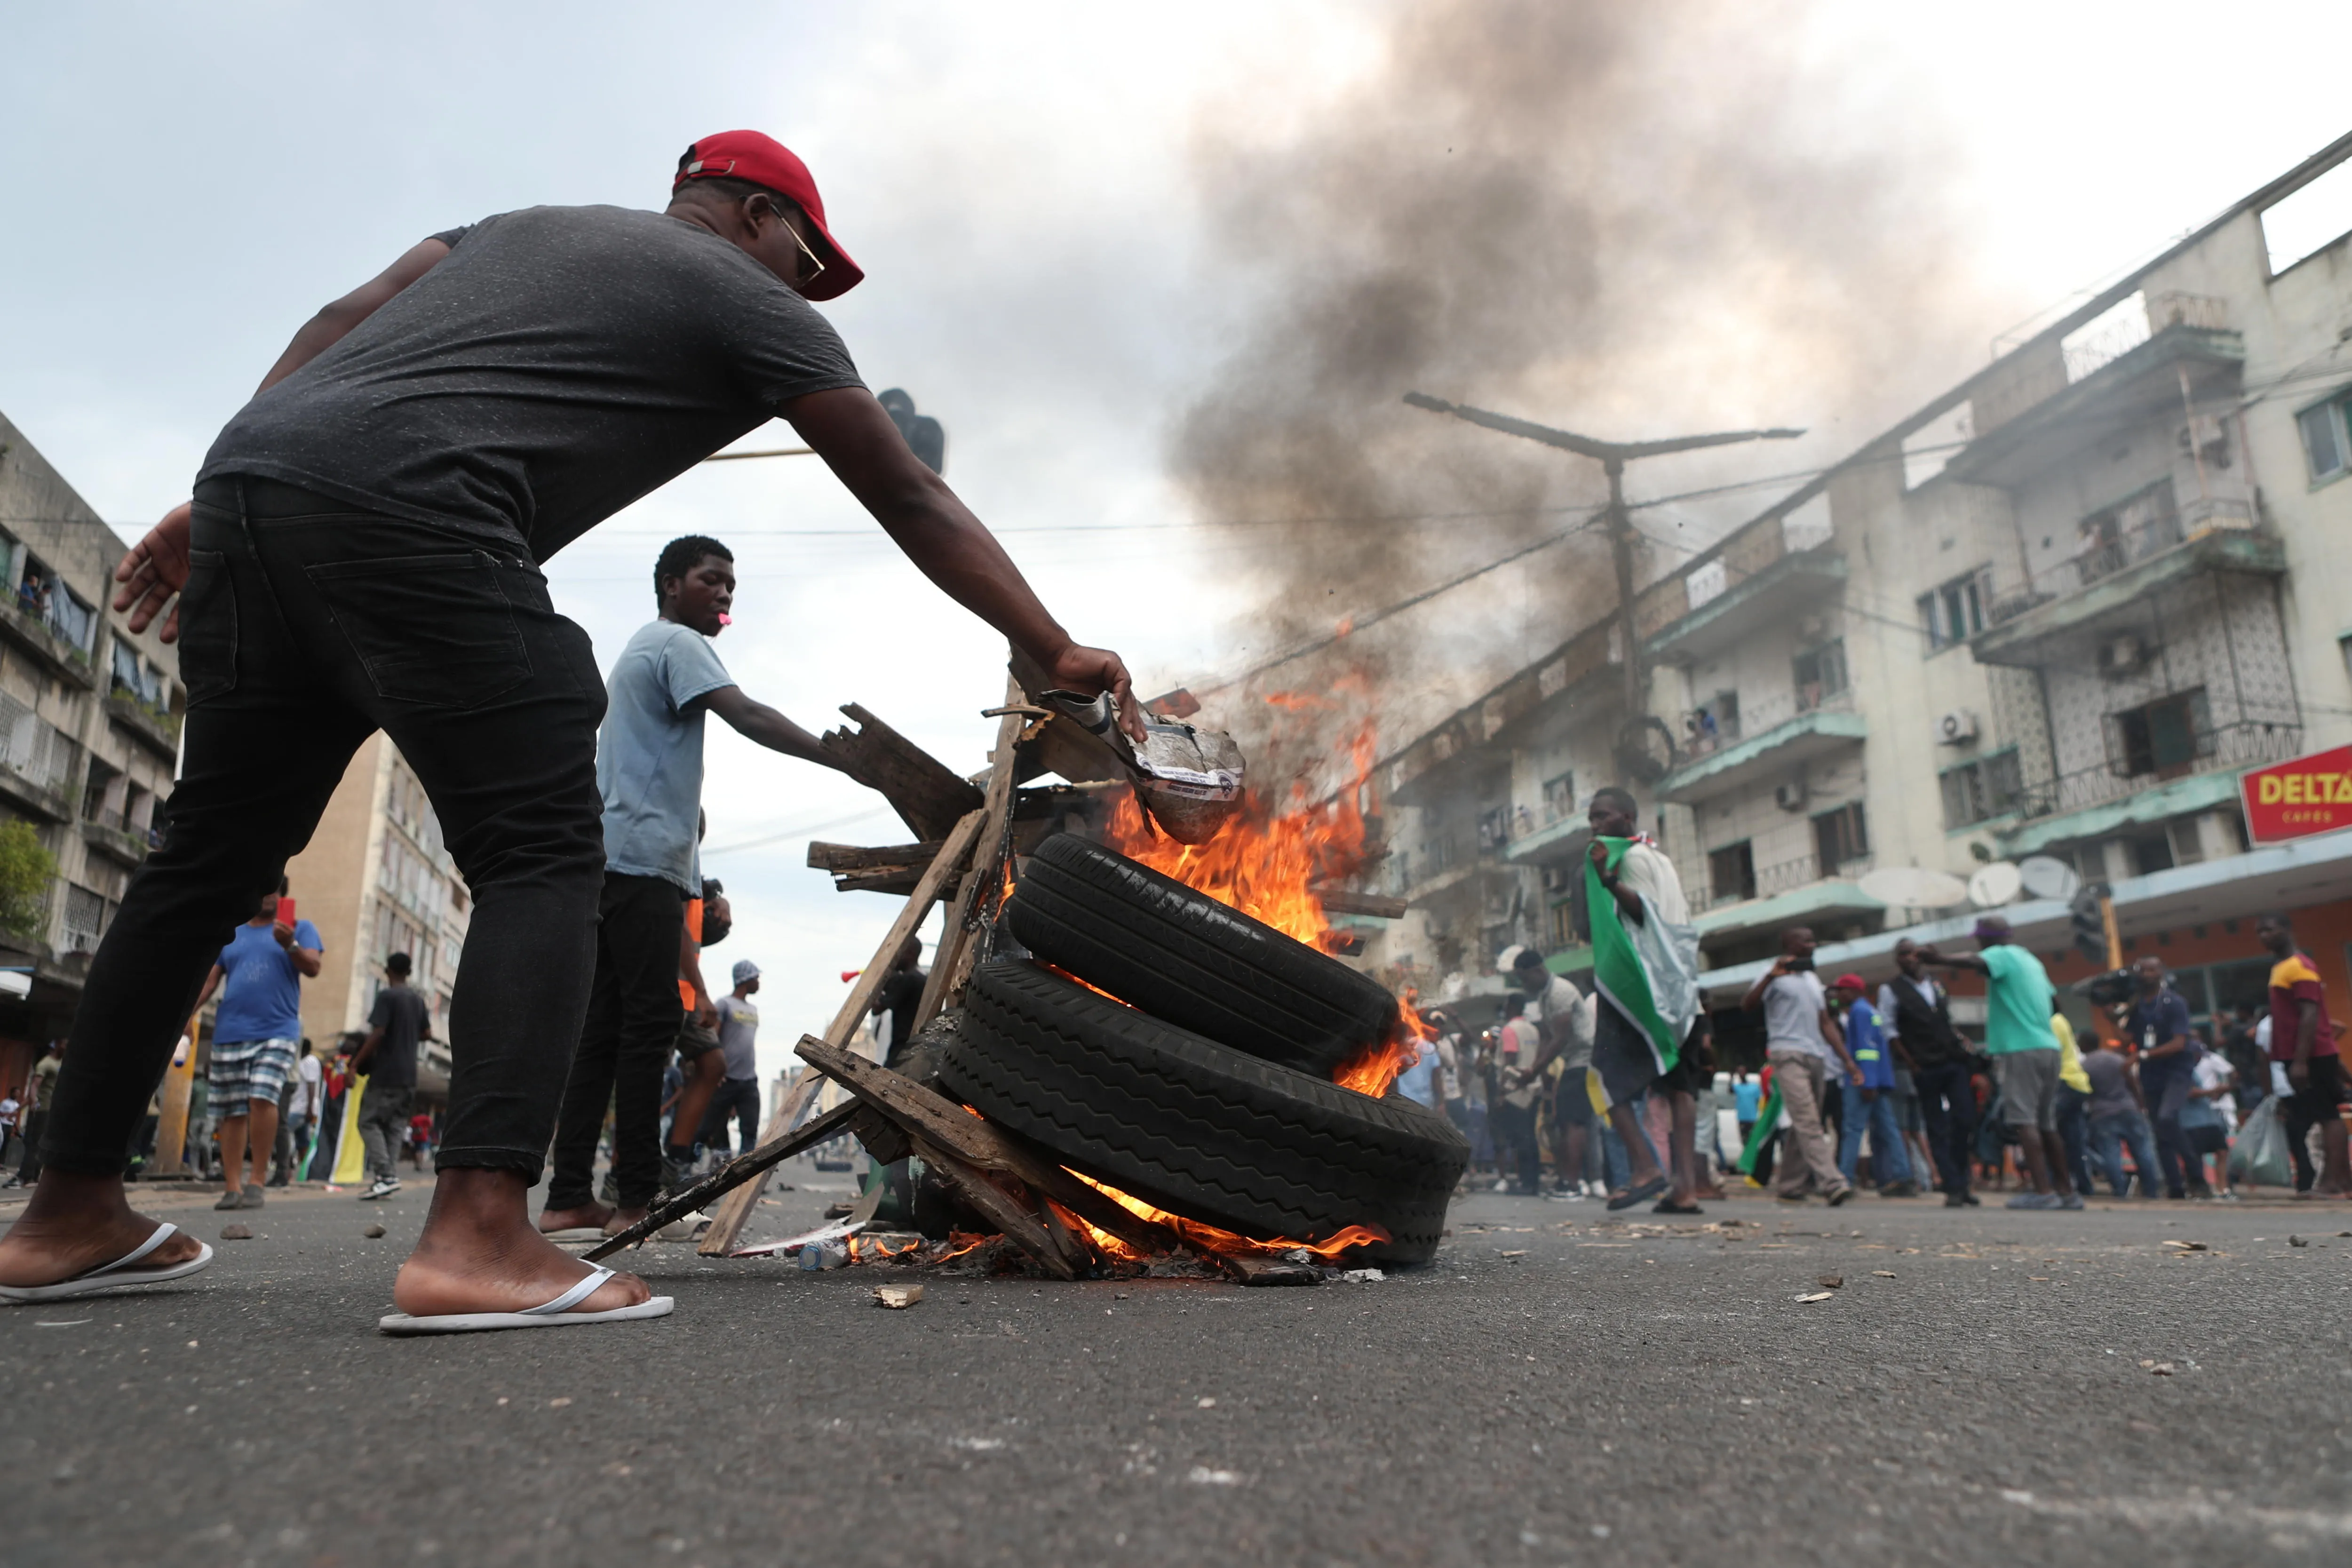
943, 959, 1470, 1262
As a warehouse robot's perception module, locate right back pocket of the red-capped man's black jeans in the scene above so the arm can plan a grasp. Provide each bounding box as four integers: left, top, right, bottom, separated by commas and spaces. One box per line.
306, 550, 532, 708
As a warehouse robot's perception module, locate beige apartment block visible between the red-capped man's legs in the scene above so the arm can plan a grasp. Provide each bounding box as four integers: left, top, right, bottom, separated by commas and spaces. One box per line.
287, 731, 473, 1093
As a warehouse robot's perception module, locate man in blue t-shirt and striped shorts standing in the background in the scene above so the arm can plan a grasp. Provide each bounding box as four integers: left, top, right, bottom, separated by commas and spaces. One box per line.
195, 879, 327, 1208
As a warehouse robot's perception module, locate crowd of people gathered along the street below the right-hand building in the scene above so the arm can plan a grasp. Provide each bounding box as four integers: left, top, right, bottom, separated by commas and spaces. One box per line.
1399, 883, 2352, 1213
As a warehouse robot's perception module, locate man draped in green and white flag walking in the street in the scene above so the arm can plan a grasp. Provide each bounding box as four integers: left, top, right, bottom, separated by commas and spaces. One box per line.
1585, 785, 1708, 1213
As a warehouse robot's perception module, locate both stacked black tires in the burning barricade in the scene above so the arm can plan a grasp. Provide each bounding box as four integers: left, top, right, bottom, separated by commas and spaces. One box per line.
941, 835, 1470, 1262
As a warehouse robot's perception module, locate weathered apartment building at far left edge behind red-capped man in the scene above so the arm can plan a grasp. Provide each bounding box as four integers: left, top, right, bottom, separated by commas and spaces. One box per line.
0, 416, 186, 1089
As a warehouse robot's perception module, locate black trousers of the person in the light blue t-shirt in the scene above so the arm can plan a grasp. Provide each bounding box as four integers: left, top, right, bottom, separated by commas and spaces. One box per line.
548, 872, 687, 1208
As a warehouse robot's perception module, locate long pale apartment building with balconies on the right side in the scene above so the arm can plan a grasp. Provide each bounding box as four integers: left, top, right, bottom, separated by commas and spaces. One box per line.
1367, 136, 2352, 1043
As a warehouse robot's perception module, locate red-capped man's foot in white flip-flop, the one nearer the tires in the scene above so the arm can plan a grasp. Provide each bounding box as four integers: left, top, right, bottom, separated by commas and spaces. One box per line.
393, 1169, 654, 1316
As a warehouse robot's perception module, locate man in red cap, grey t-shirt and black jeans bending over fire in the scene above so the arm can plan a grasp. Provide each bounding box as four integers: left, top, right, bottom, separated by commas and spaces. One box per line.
0, 132, 1143, 1333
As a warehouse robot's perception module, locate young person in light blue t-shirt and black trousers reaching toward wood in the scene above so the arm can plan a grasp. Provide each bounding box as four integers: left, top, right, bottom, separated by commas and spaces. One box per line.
539, 533, 856, 1234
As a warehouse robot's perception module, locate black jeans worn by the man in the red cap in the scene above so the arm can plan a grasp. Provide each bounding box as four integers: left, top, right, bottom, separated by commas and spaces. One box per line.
42, 479, 604, 1182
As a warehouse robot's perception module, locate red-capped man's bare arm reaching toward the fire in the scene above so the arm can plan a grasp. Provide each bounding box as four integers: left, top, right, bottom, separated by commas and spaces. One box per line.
783, 386, 1143, 740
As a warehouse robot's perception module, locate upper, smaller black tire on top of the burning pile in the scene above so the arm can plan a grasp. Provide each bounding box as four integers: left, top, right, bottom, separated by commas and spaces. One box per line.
1009, 832, 1397, 1079
